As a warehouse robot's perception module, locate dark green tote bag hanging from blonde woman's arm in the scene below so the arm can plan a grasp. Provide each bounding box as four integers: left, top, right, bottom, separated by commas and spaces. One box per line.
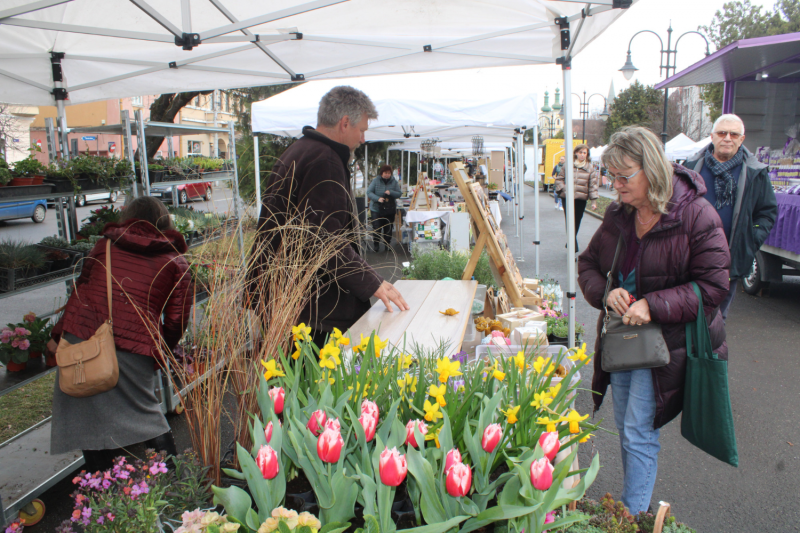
681, 282, 739, 466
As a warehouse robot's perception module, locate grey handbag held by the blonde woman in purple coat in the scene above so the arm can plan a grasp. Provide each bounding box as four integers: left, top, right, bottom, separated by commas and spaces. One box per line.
600, 234, 669, 372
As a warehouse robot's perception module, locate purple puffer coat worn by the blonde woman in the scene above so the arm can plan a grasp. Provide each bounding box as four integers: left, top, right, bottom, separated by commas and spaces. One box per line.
578, 165, 730, 428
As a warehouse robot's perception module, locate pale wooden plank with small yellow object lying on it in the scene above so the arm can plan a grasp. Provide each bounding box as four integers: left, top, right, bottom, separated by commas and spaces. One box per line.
406, 280, 478, 355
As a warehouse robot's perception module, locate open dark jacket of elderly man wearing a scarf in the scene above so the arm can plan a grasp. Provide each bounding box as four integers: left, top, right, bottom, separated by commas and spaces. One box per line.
686, 146, 778, 279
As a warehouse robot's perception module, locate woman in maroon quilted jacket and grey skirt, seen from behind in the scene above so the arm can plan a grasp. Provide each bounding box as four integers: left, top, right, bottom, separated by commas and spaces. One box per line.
48, 197, 192, 470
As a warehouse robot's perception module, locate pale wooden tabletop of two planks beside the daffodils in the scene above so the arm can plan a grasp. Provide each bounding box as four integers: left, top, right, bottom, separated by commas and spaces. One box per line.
350, 280, 478, 355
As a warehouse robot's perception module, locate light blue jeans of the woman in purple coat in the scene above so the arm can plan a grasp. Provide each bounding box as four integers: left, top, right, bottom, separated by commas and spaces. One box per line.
611, 369, 661, 515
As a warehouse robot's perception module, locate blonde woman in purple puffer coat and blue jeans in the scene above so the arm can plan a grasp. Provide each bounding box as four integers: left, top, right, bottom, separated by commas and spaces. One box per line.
578, 127, 730, 514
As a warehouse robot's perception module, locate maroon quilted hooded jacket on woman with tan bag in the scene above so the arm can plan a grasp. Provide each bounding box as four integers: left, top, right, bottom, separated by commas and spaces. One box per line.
52, 219, 193, 357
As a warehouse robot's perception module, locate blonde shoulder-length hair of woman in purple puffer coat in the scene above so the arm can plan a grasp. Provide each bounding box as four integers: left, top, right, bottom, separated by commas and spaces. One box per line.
602, 126, 674, 215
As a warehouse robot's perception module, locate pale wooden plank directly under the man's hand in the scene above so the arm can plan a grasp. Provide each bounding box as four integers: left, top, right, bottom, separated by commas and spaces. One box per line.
350, 280, 436, 344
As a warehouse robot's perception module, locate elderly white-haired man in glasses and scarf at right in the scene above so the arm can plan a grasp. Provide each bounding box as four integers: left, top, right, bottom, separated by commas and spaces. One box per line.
686, 115, 778, 320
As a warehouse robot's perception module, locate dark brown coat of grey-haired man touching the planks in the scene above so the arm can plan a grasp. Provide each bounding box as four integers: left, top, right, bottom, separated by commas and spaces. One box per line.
250, 126, 383, 331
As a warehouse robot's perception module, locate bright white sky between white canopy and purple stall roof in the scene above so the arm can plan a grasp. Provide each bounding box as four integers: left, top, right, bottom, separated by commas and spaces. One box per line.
476, 0, 774, 118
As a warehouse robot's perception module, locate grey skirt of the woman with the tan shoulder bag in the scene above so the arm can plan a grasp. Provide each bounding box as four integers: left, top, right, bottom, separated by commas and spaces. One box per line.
50, 333, 170, 455
